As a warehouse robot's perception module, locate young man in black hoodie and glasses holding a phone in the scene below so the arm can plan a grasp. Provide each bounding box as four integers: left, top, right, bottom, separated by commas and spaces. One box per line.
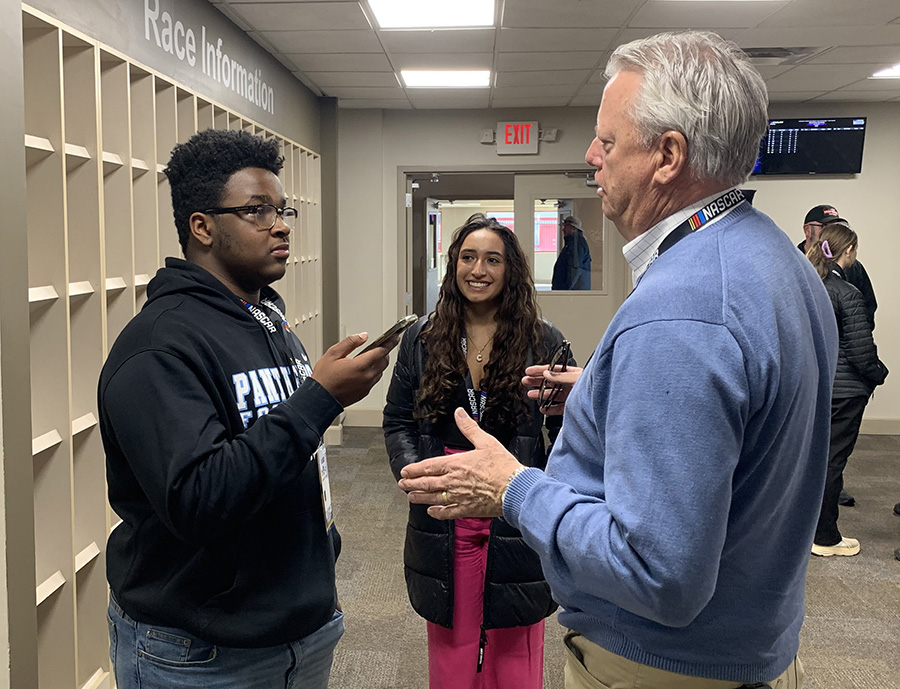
99, 130, 396, 689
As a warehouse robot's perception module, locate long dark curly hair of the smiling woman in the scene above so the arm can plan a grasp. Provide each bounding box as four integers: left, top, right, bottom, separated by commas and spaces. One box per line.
416, 213, 549, 432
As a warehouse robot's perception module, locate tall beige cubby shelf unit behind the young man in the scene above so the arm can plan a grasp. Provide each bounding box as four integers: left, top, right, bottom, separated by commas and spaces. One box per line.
22, 5, 322, 689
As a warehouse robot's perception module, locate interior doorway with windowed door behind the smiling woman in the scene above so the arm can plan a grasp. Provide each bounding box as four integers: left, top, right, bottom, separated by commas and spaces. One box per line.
406, 172, 630, 363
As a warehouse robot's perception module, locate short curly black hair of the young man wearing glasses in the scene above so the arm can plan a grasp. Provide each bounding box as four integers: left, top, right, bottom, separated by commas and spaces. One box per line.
164, 129, 284, 255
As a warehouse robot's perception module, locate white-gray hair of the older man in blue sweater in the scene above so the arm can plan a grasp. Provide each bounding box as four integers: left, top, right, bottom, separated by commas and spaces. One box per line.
606, 31, 769, 186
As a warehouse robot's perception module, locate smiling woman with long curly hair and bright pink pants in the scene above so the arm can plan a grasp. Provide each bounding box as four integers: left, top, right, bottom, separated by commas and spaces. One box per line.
383, 213, 568, 689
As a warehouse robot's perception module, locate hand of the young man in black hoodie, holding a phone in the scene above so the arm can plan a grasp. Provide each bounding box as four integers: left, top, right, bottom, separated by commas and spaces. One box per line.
312, 333, 400, 407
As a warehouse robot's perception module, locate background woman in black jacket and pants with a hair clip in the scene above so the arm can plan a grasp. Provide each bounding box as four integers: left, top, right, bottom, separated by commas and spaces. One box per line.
806, 220, 888, 557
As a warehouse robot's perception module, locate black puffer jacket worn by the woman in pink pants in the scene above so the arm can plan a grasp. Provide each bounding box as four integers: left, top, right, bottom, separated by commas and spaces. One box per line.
382, 317, 574, 629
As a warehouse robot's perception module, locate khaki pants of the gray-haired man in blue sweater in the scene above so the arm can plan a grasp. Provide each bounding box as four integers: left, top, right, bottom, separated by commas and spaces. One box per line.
564, 631, 803, 689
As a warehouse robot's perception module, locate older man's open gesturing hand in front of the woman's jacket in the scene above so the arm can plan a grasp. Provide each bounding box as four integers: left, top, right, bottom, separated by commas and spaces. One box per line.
399, 408, 522, 519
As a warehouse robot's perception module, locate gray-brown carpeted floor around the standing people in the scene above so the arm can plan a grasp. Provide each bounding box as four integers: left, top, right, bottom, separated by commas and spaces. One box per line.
328, 429, 900, 689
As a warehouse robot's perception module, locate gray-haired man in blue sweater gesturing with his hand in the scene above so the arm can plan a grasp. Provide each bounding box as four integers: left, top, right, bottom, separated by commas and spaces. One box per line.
400, 31, 838, 689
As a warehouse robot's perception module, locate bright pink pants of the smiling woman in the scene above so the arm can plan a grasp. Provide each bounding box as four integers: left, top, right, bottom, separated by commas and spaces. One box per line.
428, 519, 544, 689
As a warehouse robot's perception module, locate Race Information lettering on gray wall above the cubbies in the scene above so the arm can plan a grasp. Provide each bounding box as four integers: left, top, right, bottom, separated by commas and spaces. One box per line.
144, 0, 274, 114
